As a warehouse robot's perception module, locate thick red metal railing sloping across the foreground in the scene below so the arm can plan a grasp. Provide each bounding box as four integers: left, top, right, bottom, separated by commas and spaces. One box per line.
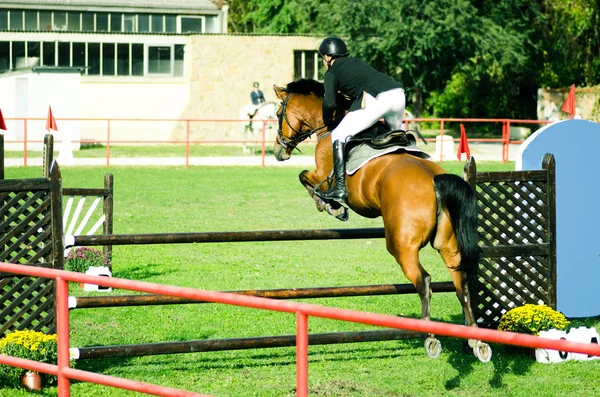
0, 262, 600, 397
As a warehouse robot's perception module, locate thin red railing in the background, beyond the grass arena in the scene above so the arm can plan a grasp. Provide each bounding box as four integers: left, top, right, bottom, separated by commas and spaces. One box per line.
0, 118, 552, 167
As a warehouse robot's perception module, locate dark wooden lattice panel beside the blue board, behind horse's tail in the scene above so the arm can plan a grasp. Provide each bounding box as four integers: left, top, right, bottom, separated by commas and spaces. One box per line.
465, 154, 556, 327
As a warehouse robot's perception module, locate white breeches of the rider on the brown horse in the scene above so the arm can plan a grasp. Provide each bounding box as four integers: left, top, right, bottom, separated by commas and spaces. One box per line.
331, 88, 406, 142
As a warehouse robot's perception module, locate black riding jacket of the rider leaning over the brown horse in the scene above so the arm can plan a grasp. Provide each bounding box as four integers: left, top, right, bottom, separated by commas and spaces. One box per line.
323, 57, 402, 125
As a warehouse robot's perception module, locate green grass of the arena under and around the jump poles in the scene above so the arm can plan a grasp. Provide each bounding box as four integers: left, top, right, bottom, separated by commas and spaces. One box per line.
0, 162, 600, 397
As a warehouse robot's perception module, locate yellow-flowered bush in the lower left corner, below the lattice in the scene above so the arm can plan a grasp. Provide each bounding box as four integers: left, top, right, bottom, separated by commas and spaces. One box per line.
0, 330, 58, 387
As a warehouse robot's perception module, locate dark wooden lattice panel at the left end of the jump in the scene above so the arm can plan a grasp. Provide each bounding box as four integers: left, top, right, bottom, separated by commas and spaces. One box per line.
0, 163, 63, 336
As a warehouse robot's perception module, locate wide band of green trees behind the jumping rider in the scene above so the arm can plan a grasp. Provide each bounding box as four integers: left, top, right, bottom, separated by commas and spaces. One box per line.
230, 0, 600, 119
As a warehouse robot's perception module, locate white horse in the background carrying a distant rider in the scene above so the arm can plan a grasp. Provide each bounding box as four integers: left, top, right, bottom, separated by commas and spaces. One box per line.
240, 102, 278, 153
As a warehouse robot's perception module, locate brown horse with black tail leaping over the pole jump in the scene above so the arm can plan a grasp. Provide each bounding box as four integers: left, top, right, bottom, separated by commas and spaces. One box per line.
274, 79, 491, 361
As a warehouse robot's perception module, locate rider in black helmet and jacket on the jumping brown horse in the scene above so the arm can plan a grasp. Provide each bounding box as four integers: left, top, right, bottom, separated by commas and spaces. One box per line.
319, 37, 406, 203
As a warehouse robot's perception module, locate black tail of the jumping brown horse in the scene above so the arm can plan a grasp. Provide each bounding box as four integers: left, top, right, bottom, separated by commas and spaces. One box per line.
433, 174, 481, 273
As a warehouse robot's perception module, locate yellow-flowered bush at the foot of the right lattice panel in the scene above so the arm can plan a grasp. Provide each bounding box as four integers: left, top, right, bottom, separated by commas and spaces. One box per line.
498, 304, 569, 335
